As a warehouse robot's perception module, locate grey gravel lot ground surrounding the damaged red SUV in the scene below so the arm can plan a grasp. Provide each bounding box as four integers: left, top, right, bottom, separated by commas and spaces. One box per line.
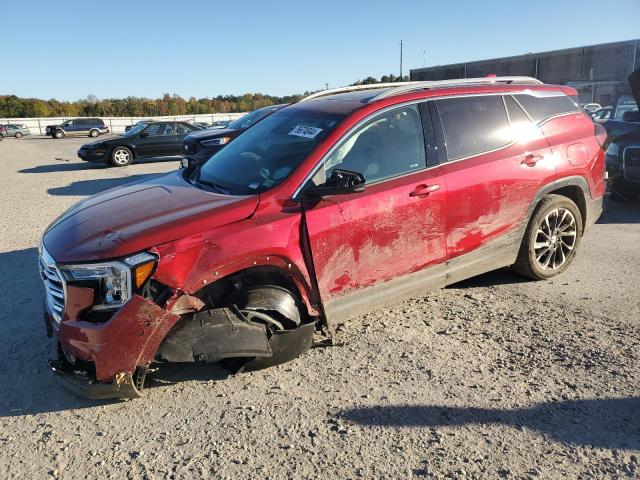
0, 137, 640, 479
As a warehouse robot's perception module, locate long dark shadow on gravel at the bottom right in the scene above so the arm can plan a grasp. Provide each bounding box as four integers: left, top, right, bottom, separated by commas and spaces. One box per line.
339, 397, 640, 450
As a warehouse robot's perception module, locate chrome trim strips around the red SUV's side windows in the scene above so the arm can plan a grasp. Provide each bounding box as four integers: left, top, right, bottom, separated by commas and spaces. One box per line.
291, 90, 577, 201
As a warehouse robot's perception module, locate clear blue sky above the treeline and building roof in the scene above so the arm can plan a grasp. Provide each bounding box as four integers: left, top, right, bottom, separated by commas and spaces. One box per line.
0, 0, 640, 100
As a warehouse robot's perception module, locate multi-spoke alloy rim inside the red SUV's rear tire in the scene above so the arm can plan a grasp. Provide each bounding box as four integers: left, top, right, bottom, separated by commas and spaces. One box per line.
533, 208, 577, 270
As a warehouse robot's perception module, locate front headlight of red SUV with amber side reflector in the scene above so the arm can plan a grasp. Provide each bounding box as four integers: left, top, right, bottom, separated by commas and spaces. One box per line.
58, 252, 156, 310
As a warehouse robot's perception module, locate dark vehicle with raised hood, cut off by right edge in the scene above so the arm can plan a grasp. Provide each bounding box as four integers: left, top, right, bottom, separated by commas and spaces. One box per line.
606, 69, 640, 199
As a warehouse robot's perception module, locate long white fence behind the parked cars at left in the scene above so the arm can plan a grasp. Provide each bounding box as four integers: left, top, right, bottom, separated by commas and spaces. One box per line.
0, 113, 246, 135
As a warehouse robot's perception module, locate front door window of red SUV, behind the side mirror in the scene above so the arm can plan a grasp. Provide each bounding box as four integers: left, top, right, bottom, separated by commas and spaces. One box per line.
314, 105, 426, 184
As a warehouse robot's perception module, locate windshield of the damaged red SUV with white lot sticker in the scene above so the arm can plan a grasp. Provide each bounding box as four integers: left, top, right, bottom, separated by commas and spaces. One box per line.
191, 108, 345, 195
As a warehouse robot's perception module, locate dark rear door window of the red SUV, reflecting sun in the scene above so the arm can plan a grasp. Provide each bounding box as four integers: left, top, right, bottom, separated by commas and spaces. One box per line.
435, 95, 511, 161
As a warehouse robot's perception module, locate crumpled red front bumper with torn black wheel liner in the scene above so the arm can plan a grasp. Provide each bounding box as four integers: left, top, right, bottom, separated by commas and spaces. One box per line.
45, 295, 316, 399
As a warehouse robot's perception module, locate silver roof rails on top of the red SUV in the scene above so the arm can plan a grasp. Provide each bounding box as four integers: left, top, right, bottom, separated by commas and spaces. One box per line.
298, 77, 543, 102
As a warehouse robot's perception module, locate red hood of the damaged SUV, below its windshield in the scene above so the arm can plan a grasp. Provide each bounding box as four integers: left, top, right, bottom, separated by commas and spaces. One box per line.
43, 171, 259, 263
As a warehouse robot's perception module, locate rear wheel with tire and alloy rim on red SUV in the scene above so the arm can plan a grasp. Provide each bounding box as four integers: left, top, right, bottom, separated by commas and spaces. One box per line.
513, 194, 583, 280
